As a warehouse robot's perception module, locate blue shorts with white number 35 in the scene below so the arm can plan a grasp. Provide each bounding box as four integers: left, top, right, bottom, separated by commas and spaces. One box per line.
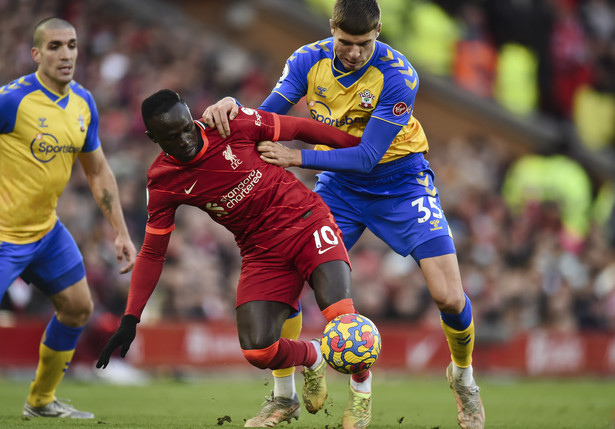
314, 154, 455, 262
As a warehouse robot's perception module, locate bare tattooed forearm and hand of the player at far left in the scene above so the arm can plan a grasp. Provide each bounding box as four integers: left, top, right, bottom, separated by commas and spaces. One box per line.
79, 148, 137, 274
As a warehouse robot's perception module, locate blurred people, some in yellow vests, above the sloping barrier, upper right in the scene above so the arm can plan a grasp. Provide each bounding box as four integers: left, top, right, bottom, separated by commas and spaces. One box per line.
307, 0, 615, 152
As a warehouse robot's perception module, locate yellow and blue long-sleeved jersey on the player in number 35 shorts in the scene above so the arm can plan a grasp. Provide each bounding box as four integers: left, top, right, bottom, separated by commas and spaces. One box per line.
261, 38, 429, 171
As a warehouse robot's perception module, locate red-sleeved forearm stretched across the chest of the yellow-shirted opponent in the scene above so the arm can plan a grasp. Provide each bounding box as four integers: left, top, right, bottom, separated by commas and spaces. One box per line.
279, 116, 361, 148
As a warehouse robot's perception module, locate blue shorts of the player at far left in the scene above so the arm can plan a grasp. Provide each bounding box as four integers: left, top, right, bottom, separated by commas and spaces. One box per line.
0, 220, 85, 300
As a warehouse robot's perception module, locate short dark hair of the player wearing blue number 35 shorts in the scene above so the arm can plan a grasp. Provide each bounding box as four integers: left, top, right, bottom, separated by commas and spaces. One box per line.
331, 0, 380, 36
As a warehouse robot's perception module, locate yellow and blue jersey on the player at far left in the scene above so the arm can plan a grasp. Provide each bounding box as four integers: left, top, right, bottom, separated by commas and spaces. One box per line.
0, 73, 100, 244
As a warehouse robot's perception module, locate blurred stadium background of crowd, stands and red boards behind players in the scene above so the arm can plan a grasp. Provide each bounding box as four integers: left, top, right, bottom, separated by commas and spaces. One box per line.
0, 0, 615, 376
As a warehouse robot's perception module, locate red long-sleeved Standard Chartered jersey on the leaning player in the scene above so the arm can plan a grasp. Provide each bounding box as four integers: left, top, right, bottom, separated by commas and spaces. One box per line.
126, 107, 359, 317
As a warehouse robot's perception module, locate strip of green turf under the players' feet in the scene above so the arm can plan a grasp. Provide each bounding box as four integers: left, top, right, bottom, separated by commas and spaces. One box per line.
0, 371, 615, 429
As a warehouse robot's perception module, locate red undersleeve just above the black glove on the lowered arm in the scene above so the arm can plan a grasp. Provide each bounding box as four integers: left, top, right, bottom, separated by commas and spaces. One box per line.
125, 232, 171, 319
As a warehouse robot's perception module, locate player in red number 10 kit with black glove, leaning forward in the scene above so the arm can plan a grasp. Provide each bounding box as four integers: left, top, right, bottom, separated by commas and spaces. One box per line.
96, 90, 371, 428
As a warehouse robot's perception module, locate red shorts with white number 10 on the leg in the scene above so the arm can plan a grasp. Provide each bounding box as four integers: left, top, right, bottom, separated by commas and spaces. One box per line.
235, 214, 350, 311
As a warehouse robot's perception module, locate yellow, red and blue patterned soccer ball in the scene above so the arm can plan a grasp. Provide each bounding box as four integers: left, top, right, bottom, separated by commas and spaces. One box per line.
320, 314, 382, 374
